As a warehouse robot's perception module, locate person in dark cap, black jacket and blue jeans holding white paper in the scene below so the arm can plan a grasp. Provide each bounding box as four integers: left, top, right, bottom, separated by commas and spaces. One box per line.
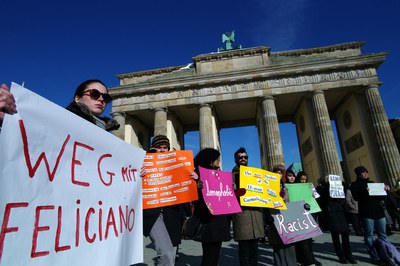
350, 165, 388, 265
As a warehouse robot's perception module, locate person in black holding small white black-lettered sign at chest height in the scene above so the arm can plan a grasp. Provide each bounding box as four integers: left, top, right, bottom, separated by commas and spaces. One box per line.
320, 177, 357, 264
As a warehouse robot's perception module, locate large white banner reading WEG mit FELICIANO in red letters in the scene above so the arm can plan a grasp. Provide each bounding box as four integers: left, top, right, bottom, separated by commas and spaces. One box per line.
0, 83, 145, 265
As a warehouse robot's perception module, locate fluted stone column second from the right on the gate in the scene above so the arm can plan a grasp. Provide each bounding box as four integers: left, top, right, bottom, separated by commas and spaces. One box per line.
311, 91, 343, 177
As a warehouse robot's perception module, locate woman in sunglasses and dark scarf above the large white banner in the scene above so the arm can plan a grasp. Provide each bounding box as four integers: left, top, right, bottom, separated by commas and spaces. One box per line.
67, 79, 119, 131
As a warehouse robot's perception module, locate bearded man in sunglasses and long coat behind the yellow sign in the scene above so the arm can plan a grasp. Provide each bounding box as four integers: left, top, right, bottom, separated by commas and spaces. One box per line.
232, 147, 265, 266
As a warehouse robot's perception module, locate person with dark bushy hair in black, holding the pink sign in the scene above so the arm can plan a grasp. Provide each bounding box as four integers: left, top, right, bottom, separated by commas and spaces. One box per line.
194, 148, 231, 266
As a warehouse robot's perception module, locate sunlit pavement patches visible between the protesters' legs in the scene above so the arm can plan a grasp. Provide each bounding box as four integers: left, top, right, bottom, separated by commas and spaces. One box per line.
140, 231, 400, 266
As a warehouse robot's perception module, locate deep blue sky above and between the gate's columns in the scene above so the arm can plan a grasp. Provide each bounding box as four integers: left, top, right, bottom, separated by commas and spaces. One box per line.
0, 0, 400, 171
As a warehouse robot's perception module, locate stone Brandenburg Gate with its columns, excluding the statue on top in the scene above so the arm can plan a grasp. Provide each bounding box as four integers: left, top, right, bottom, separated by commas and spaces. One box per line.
110, 42, 400, 185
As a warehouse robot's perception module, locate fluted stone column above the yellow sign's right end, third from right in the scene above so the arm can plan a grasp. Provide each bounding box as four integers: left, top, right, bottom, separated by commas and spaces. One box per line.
261, 96, 284, 171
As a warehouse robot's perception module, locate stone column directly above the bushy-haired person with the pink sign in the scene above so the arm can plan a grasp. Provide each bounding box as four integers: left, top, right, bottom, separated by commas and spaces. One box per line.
199, 103, 214, 150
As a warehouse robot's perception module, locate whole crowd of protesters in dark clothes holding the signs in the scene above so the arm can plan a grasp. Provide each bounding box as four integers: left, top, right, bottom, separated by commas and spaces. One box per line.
0, 80, 400, 266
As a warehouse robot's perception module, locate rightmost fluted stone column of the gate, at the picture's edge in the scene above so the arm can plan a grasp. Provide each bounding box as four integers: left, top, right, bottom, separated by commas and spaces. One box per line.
364, 85, 400, 186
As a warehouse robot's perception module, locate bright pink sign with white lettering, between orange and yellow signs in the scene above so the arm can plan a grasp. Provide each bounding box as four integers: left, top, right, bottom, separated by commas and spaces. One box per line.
200, 167, 242, 215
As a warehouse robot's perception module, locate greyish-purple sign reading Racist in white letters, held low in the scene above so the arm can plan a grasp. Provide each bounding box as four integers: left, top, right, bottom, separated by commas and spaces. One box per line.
271, 201, 322, 244
